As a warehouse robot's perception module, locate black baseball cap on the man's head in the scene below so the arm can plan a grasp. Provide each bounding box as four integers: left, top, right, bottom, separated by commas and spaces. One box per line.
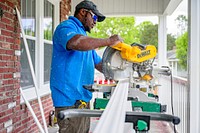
76, 0, 106, 22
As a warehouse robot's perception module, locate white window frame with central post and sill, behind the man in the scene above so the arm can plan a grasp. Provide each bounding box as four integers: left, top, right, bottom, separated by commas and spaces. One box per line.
20, 0, 60, 103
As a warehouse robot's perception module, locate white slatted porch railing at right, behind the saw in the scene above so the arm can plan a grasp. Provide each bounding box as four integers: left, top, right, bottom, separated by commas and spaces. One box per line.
159, 76, 189, 133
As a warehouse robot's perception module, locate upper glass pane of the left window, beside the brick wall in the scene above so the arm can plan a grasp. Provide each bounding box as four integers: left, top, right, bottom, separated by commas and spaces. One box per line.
21, 0, 35, 36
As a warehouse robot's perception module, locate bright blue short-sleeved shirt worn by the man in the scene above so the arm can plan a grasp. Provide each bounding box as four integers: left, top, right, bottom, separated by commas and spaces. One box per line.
50, 16, 101, 107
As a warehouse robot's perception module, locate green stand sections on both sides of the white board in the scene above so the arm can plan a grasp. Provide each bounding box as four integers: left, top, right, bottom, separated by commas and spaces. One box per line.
94, 98, 166, 112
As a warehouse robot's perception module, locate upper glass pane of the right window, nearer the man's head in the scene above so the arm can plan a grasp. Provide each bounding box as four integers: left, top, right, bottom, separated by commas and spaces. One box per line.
44, 0, 54, 40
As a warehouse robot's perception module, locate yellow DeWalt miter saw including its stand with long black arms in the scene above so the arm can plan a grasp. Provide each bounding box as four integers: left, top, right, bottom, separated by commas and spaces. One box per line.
58, 43, 180, 133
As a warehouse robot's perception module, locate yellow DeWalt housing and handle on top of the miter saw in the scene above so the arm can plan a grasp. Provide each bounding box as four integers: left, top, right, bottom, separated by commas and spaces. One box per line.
112, 42, 157, 63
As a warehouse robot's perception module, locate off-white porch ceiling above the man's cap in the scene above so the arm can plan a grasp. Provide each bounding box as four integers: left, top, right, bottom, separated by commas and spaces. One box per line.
71, 0, 182, 16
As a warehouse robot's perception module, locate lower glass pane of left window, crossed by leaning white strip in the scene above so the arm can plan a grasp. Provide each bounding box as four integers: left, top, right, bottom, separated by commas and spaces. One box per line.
20, 39, 35, 89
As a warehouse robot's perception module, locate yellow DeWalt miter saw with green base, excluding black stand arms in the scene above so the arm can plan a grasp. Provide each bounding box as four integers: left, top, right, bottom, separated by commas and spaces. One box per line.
91, 43, 166, 112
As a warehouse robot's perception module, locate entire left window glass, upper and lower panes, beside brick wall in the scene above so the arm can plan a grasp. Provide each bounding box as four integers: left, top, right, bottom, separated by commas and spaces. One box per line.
20, 0, 36, 89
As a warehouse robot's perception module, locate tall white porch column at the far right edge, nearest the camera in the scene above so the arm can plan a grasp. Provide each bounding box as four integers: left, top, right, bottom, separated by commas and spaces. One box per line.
188, 0, 200, 133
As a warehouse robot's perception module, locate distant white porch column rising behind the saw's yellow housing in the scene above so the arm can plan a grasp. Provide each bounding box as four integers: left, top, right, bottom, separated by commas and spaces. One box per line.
158, 15, 168, 67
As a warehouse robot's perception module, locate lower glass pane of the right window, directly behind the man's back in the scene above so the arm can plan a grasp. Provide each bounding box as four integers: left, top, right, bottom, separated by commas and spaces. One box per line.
44, 43, 52, 83
